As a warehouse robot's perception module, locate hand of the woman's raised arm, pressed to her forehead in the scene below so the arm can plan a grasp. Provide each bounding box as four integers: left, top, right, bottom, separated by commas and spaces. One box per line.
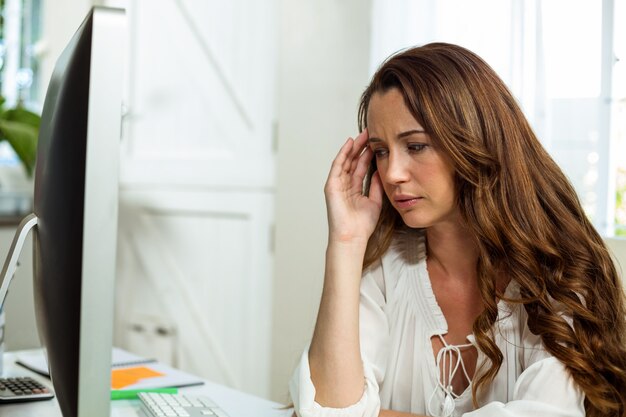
324, 130, 383, 243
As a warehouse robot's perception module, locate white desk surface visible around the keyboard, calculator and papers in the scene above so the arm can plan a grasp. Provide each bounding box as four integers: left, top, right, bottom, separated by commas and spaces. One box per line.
0, 352, 292, 417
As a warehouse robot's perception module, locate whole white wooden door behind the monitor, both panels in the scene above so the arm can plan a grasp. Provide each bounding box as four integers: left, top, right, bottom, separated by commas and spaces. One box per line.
110, 0, 275, 396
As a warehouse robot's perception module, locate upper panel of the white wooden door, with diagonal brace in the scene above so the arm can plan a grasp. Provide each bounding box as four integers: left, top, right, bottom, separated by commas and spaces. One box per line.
122, 0, 275, 187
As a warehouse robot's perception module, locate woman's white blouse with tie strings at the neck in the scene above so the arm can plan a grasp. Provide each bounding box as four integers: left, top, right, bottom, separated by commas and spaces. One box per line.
290, 232, 585, 417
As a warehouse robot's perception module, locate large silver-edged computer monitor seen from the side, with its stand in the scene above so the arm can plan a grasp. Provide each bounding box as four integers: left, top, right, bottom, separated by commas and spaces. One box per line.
0, 7, 126, 417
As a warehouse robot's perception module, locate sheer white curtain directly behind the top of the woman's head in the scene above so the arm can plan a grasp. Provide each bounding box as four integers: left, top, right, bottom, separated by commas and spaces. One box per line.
370, 0, 549, 141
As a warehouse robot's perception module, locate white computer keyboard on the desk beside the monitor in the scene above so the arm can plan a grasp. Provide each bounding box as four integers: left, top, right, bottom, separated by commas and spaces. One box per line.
138, 392, 229, 417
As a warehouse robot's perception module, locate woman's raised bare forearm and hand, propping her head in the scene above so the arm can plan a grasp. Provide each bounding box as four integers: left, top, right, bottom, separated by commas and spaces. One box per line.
309, 132, 382, 408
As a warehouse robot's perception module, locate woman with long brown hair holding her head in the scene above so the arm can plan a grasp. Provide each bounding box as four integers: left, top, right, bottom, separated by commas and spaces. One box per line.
290, 43, 626, 417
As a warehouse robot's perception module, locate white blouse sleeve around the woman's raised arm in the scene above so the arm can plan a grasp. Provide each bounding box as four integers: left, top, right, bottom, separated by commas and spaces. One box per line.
289, 263, 389, 417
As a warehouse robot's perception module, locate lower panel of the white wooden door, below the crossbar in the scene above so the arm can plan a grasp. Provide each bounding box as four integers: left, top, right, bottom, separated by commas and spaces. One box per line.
116, 192, 272, 396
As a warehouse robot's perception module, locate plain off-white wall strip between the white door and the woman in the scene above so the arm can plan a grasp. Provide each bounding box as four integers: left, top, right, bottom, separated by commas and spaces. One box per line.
271, 0, 370, 402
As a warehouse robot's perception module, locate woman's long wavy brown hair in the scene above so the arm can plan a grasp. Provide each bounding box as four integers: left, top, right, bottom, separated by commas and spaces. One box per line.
359, 43, 626, 417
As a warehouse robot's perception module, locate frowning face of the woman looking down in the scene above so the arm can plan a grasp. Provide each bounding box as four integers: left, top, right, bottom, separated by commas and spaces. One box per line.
367, 88, 459, 228
